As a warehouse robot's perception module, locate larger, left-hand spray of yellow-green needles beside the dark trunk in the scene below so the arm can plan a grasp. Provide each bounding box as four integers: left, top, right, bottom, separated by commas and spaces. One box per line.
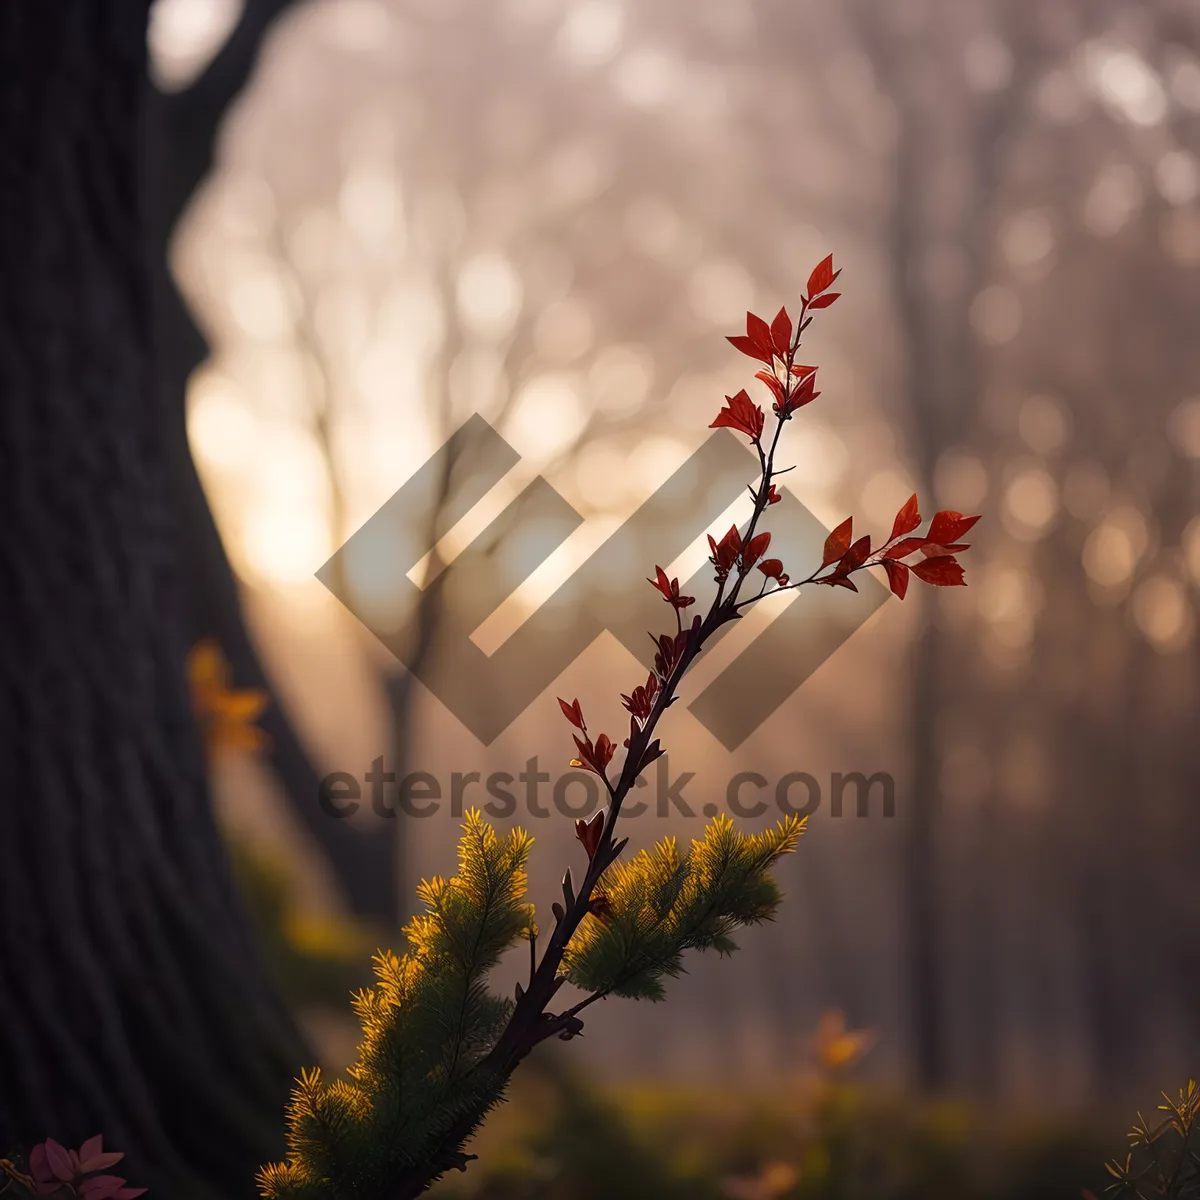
259, 811, 535, 1200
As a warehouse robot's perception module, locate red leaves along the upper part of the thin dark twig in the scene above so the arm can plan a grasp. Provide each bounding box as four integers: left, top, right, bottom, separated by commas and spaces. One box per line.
558, 254, 979, 860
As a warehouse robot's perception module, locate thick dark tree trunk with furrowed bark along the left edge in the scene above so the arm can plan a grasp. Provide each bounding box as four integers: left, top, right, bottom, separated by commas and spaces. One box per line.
0, 0, 304, 1200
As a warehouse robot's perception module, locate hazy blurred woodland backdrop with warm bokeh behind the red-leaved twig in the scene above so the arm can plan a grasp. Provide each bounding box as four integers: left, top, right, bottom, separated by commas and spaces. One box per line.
0, 0, 1200, 1196
